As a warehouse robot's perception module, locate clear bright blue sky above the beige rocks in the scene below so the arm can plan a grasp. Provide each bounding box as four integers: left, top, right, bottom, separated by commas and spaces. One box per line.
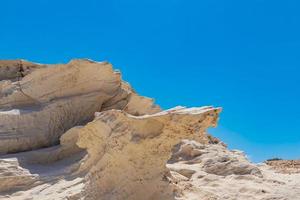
0, 0, 300, 161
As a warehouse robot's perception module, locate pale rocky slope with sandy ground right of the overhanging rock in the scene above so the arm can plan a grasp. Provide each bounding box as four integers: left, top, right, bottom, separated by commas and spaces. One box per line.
167, 140, 300, 200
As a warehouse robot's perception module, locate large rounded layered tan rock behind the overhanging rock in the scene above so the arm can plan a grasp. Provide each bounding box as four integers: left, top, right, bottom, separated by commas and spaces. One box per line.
0, 60, 160, 153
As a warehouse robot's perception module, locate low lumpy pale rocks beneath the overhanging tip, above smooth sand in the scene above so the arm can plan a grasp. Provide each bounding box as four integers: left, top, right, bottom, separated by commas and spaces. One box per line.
168, 140, 262, 178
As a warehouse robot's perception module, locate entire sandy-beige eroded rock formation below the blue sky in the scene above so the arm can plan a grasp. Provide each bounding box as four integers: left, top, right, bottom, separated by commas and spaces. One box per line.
0, 59, 300, 200
